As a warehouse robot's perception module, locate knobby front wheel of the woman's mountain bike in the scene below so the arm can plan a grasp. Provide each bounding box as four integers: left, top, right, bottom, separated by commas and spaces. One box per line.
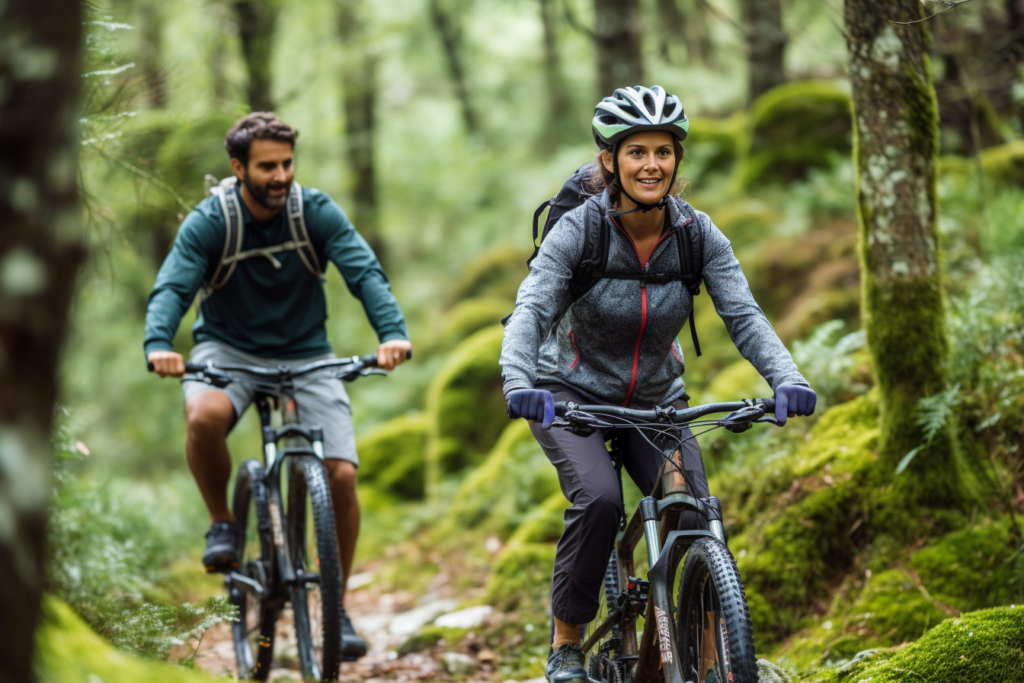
676, 538, 758, 683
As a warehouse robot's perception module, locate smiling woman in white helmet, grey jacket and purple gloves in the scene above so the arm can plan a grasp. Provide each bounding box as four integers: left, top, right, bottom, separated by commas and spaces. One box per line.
501, 85, 816, 683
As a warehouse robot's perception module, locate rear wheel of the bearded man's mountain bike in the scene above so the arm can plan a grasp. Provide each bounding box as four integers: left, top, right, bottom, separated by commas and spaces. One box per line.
228, 460, 279, 681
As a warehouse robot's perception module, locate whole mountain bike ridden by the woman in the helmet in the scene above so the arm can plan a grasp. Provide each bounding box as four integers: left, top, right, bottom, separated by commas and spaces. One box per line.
552, 398, 775, 683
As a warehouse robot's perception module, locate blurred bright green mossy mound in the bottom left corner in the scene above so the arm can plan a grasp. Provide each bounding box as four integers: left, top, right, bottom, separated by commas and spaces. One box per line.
36, 596, 214, 683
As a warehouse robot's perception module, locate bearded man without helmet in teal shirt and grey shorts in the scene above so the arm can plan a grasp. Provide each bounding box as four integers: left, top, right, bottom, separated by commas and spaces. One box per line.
144, 113, 412, 657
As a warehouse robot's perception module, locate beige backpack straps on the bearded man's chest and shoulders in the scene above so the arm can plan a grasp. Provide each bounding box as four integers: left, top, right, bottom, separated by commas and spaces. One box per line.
203, 175, 323, 298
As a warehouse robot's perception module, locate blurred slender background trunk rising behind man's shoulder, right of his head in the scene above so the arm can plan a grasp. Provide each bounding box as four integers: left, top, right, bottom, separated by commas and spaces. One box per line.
338, 0, 385, 263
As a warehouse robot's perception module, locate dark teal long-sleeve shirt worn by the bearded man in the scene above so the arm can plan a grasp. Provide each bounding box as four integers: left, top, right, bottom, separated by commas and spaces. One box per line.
143, 187, 408, 358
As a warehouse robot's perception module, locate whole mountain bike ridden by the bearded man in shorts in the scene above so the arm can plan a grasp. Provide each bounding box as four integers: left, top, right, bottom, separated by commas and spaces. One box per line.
174, 354, 401, 681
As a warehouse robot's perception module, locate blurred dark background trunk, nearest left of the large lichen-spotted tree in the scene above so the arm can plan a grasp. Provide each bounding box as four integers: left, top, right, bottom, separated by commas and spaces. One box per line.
743, 0, 786, 102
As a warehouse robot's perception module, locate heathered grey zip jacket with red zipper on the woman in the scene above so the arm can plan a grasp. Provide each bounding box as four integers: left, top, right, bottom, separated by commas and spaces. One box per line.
501, 193, 808, 409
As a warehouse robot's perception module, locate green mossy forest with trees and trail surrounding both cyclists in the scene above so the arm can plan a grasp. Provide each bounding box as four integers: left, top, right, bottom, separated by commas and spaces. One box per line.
0, 0, 1024, 683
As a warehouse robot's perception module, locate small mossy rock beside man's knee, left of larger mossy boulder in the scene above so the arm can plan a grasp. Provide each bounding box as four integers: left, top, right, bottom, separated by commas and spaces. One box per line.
356, 414, 429, 499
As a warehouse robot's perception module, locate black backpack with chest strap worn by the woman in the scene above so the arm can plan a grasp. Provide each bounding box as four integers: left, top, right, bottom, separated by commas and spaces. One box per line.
524, 166, 703, 355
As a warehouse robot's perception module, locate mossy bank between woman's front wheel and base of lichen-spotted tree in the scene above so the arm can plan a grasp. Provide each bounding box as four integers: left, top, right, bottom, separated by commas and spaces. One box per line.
722, 393, 879, 639
